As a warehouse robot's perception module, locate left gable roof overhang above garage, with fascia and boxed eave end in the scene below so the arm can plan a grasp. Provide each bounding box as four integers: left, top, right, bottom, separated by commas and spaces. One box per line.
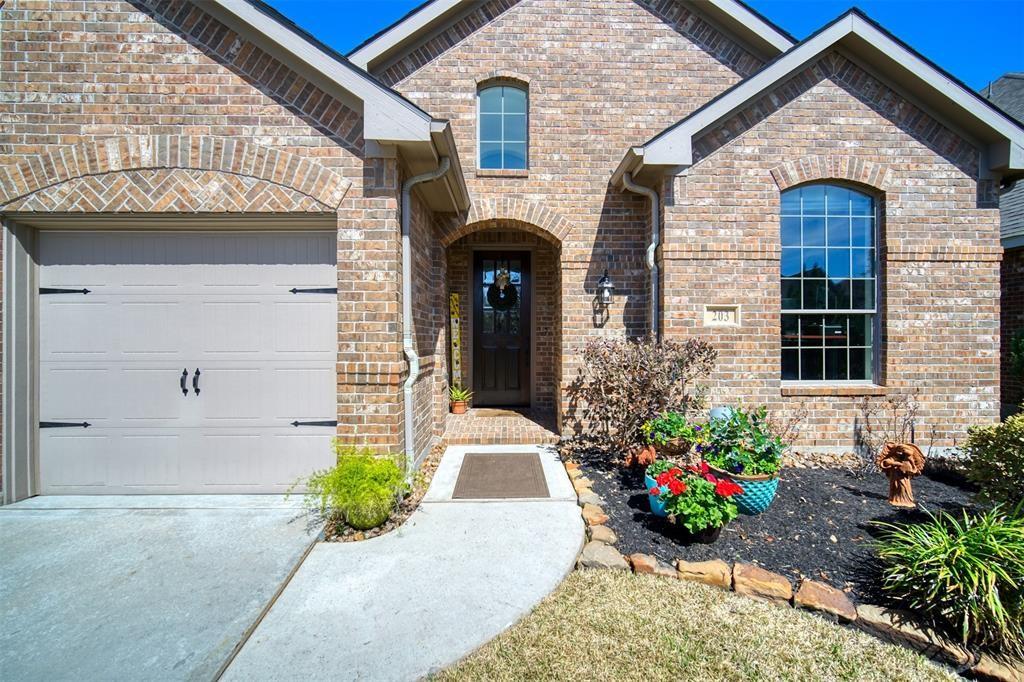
202, 0, 469, 210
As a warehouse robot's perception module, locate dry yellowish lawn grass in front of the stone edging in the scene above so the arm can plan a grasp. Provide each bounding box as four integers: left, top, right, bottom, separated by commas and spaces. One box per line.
437, 570, 956, 682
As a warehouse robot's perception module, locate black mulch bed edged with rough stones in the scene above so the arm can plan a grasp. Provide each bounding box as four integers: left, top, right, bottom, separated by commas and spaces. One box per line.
581, 458, 972, 598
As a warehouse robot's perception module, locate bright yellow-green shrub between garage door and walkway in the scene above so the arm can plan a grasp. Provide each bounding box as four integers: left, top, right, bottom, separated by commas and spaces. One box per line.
304, 442, 408, 530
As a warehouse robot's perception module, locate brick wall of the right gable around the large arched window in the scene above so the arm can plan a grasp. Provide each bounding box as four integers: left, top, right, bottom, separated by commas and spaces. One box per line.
664, 55, 1000, 447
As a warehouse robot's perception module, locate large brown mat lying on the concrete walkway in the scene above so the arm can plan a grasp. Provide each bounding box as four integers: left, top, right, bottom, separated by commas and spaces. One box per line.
452, 453, 550, 500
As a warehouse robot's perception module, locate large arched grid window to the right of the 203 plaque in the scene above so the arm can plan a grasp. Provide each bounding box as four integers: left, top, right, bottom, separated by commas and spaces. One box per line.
781, 184, 878, 382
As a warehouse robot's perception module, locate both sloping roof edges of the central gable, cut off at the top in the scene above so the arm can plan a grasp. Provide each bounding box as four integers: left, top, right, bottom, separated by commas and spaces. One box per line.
348, 0, 796, 71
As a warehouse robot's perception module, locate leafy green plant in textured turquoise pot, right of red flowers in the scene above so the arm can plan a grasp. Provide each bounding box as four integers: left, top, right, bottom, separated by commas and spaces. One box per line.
700, 407, 785, 516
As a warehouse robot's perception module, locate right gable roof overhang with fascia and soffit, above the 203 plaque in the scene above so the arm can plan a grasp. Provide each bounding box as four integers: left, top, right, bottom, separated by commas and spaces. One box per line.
612, 9, 1024, 183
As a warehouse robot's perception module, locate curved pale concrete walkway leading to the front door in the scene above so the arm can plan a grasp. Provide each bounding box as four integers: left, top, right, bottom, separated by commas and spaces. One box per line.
224, 445, 584, 681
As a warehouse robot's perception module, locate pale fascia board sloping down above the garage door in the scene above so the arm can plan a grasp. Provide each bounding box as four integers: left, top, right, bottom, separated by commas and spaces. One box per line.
208, 0, 431, 141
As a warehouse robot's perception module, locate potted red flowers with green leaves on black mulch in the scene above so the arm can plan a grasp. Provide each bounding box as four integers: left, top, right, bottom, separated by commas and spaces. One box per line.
648, 462, 743, 543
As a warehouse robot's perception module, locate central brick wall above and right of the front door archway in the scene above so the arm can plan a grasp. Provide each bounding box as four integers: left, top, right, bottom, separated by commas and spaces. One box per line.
378, 0, 760, 430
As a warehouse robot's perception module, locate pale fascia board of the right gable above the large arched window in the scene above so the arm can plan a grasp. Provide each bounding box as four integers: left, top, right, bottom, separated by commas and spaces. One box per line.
644, 13, 1024, 170
